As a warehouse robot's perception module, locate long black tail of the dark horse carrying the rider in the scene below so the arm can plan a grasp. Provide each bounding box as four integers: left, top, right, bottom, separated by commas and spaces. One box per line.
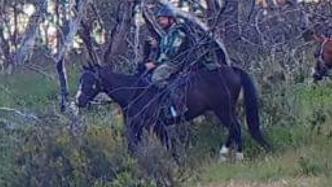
233, 67, 271, 151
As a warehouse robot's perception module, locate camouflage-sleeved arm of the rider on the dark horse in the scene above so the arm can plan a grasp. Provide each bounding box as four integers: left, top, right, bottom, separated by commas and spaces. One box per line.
157, 29, 186, 65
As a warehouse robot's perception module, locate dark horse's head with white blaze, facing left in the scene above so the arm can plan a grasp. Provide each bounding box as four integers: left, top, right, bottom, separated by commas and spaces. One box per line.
75, 66, 102, 108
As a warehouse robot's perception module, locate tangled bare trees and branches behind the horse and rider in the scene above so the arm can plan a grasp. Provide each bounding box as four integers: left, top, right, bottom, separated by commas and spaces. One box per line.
0, 0, 331, 73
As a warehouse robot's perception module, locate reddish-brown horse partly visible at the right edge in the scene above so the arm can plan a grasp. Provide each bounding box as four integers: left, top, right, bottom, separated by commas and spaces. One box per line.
303, 30, 332, 81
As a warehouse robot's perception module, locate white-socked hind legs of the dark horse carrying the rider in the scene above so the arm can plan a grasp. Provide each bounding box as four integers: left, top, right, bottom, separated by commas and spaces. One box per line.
215, 110, 243, 161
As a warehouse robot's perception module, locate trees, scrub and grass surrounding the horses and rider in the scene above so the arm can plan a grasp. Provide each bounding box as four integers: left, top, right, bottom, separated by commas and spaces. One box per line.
0, 0, 332, 186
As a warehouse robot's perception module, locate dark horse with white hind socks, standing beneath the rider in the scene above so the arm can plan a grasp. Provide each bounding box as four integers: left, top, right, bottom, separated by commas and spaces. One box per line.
76, 66, 270, 159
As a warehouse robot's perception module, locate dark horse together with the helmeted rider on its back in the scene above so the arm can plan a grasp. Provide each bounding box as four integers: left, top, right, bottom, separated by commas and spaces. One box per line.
75, 8, 271, 156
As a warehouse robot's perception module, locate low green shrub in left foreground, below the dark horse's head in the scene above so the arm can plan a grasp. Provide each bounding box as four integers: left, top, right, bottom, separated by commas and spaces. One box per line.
4, 113, 144, 186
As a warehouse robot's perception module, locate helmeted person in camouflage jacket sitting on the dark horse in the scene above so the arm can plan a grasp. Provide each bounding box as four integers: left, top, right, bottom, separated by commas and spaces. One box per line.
144, 6, 220, 117
